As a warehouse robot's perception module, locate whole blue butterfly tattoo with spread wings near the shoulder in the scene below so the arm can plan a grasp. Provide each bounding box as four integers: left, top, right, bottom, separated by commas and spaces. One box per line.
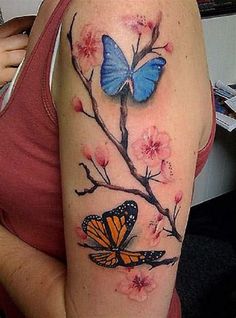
101, 35, 166, 103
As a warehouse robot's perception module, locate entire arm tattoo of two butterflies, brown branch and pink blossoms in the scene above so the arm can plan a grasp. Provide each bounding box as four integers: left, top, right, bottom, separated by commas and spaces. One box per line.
67, 13, 183, 301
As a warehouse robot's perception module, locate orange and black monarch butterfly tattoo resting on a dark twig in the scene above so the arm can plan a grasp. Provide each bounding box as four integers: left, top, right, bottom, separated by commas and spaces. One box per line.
78, 201, 178, 269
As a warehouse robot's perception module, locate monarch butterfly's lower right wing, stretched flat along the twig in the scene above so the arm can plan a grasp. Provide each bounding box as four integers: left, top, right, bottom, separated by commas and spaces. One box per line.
117, 250, 165, 267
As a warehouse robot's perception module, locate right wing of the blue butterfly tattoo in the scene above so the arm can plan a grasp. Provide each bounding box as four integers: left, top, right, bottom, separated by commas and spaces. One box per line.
132, 57, 166, 102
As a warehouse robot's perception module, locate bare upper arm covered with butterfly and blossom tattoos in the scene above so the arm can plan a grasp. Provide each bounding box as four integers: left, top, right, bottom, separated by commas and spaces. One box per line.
54, 0, 210, 318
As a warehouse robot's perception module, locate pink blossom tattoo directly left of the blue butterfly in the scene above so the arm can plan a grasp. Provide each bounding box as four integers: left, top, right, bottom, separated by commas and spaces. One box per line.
73, 24, 102, 73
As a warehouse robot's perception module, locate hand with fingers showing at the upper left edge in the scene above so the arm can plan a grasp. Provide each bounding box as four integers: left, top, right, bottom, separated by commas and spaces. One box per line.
0, 16, 35, 87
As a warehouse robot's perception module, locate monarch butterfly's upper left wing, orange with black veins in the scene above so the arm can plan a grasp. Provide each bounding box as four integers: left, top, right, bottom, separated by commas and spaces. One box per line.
82, 215, 111, 249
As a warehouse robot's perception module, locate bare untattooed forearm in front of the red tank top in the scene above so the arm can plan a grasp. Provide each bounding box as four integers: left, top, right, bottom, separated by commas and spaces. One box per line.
0, 226, 66, 318
